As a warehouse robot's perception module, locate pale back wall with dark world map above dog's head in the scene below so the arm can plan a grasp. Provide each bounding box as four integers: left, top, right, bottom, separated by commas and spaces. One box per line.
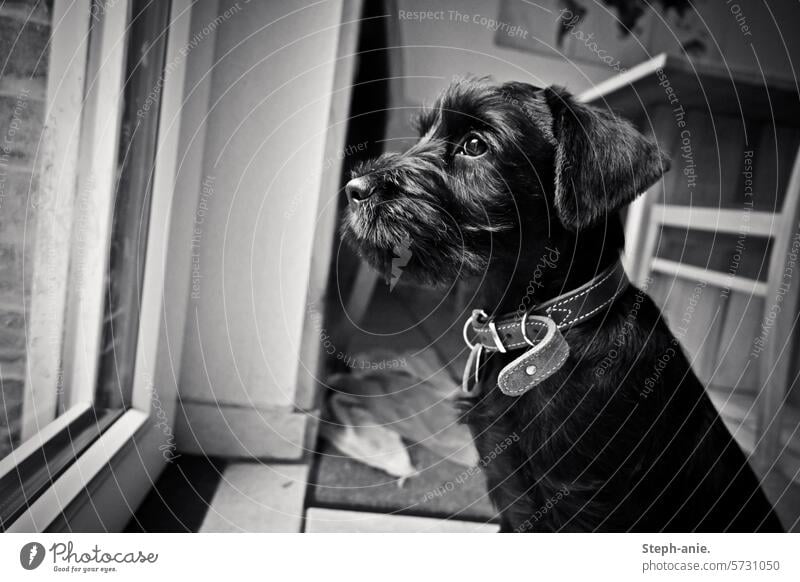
390, 0, 800, 108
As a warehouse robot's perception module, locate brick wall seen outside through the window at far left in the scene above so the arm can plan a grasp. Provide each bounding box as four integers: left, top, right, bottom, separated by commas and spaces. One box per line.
0, 0, 52, 458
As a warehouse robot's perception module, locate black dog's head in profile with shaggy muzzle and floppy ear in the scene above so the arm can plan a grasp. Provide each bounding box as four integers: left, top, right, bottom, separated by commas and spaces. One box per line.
343, 80, 668, 284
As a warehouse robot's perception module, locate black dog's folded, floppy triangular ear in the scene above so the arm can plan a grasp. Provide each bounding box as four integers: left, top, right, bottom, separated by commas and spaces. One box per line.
542, 87, 669, 230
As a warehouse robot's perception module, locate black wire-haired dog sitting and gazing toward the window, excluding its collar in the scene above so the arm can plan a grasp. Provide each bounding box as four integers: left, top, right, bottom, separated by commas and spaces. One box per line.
343, 80, 781, 532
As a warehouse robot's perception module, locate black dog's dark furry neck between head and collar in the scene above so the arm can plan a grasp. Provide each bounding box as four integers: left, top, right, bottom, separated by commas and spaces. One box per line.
478, 221, 624, 316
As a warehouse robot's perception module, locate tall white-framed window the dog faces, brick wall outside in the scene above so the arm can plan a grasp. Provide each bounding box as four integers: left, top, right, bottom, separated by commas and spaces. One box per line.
0, 0, 191, 531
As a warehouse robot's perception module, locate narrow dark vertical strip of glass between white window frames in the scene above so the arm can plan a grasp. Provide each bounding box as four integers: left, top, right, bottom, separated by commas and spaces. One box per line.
95, 0, 169, 408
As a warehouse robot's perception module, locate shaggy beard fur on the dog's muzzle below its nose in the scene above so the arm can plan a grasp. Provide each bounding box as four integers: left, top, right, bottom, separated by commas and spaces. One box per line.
342, 198, 488, 286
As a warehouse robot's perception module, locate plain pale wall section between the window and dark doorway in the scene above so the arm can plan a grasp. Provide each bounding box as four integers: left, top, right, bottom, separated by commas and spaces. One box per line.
178, 0, 343, 457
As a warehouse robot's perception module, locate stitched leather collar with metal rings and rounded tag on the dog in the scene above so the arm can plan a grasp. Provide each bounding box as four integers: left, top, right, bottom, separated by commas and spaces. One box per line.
462, 261, 629, 396
